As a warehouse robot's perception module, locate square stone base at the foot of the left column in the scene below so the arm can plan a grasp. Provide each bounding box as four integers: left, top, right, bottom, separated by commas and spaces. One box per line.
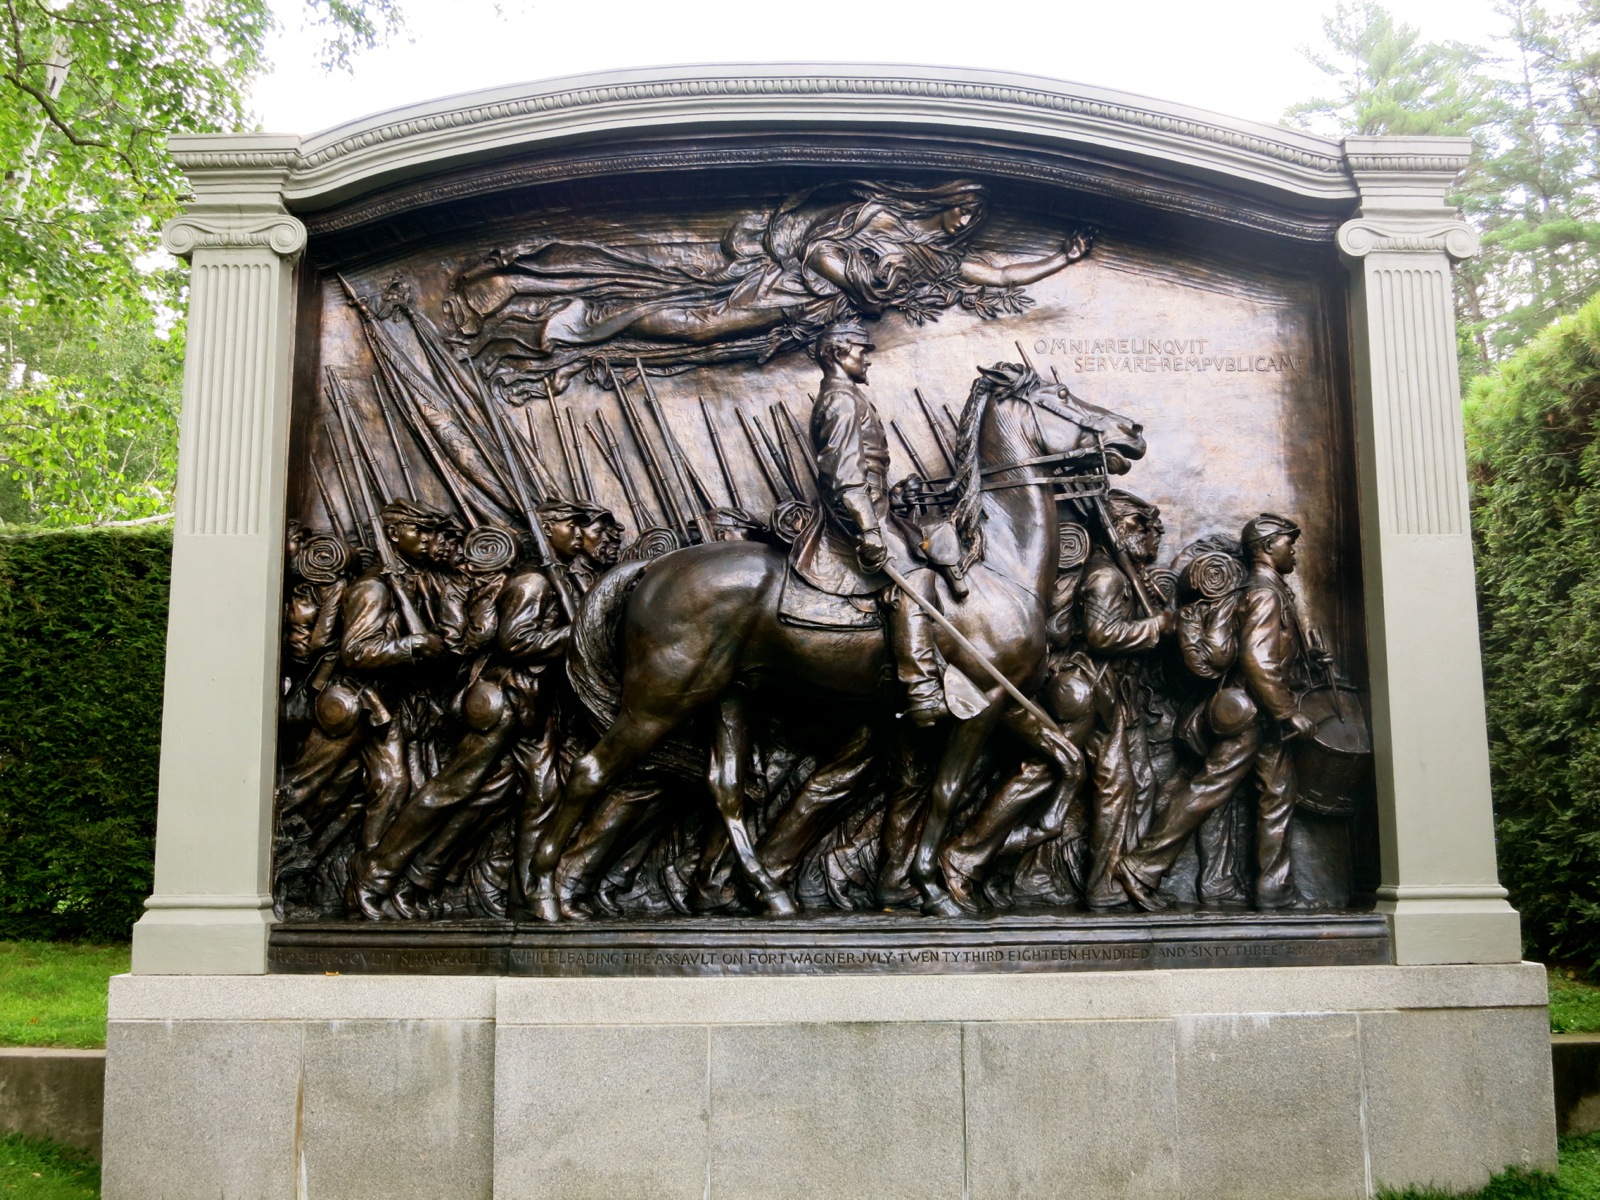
133, 894, 275, 974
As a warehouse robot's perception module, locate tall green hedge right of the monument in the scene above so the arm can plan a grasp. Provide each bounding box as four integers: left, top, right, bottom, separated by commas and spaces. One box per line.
1467, 299, 1600, 968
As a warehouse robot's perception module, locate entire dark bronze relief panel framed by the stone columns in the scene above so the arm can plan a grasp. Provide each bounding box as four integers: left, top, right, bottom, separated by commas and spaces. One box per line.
272, 136, 1387, 974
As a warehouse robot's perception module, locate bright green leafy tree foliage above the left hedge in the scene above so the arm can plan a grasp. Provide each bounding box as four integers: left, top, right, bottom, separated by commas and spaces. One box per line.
0, 0, 398, 525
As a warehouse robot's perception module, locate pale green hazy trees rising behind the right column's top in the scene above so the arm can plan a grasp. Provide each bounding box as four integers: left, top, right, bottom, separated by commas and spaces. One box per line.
1285, 0, 1600, 378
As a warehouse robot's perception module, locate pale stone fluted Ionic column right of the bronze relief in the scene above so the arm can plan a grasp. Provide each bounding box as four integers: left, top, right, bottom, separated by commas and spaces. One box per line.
1339, 138, 1522, 963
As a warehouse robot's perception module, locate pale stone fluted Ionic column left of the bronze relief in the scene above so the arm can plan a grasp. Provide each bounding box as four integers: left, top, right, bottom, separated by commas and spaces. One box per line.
133, 136, 306, 974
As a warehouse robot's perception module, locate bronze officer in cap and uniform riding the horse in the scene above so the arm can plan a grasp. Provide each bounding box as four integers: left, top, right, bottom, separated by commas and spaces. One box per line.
790, 322, 950, 725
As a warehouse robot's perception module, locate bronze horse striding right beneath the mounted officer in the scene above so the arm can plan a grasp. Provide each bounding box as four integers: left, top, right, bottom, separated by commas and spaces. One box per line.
525, 363, 1146, 922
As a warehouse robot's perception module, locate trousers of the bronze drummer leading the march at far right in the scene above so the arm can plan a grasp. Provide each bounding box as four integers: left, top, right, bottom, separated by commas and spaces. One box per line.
1123, 722, 1294, 909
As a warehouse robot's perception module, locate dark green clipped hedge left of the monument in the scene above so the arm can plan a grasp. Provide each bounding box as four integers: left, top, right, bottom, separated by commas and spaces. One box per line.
0, 528, 173, 941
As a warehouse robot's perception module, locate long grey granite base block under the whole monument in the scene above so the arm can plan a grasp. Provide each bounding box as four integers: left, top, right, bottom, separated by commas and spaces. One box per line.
104, 965, 1555, 1200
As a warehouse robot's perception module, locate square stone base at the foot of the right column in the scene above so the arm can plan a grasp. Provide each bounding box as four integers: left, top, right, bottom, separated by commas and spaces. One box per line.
1376, 883, 1522, 966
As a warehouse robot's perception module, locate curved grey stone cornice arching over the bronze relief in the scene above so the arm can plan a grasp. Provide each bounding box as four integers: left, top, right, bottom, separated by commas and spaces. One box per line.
173, 64, 1357, 211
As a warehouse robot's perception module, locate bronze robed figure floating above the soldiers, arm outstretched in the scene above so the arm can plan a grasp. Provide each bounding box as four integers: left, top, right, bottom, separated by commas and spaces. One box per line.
445, 179, 1091, 395
